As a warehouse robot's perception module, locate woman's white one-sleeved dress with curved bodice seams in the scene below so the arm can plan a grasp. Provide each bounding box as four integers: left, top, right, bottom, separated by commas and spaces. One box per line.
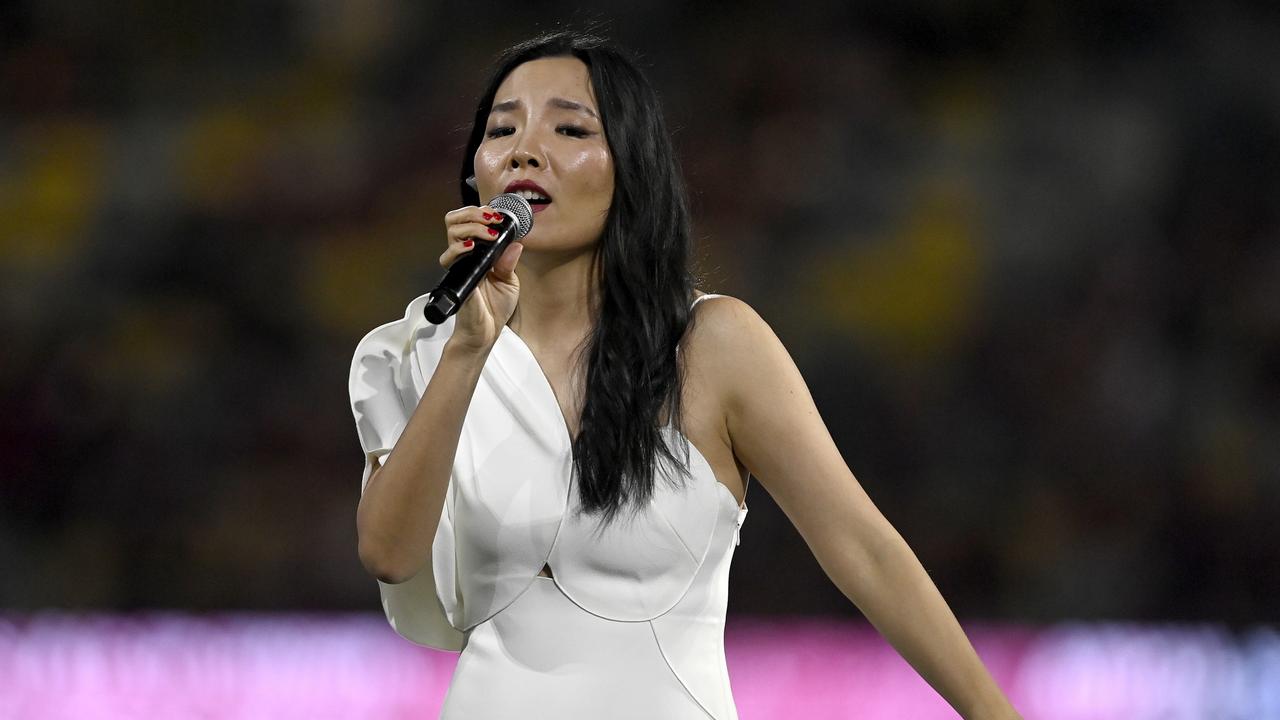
349, 289, 746, 720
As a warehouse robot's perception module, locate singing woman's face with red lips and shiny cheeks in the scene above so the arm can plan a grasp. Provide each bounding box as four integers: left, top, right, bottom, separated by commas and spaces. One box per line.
475, 58, 613, 252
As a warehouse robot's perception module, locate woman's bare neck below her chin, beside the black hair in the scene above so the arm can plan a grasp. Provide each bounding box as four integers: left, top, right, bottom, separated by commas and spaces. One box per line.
507, 247, 593, 347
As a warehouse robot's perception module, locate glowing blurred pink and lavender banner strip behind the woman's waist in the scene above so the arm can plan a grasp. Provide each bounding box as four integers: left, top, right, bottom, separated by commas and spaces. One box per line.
0, 614, 1280, 720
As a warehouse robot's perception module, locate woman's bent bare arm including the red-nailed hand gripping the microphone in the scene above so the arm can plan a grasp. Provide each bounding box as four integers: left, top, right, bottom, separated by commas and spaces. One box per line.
356, 206, 524, 583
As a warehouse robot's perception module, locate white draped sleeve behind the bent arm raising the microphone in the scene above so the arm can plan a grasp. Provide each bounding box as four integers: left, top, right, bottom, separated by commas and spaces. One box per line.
348, 296, 463, 651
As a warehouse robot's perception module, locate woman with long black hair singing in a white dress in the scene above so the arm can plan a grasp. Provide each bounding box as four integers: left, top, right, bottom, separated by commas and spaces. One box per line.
351, 33, 1016, 719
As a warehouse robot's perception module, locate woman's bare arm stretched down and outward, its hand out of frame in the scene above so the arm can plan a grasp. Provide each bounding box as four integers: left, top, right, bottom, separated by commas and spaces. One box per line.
698, 297, 1019, 720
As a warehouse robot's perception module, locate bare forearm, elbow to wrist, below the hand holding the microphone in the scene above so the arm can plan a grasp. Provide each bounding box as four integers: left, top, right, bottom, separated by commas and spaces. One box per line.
356, 340, 489, 583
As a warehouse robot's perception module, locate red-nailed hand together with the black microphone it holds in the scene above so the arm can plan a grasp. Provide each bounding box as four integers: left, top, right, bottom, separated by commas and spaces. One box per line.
424, 193, 534, 351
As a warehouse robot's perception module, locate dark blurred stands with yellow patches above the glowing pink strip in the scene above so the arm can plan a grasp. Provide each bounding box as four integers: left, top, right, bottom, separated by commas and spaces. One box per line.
0, 0, 1280, 717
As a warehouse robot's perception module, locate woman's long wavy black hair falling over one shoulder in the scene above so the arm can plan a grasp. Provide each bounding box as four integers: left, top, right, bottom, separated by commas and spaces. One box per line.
458, 32, 694, 525
